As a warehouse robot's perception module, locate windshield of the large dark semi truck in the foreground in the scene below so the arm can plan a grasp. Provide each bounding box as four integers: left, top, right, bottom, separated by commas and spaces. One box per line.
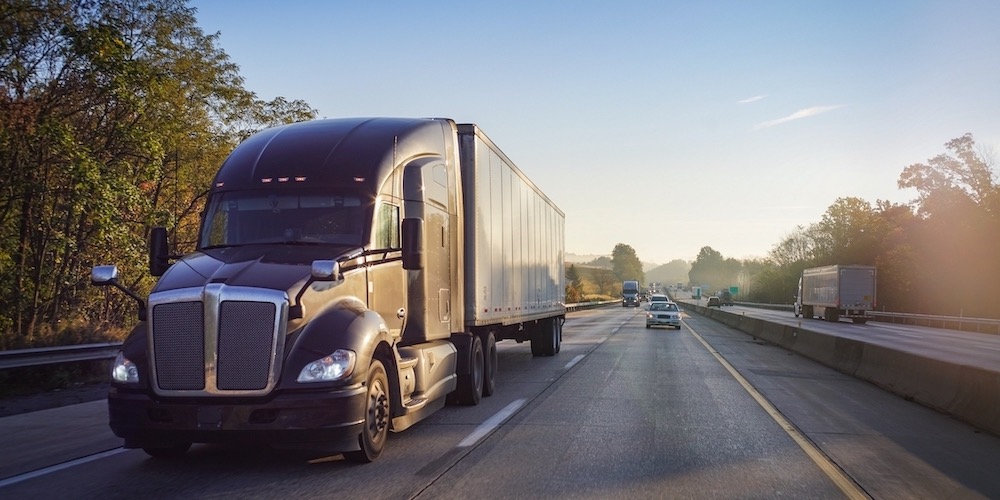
198, 191, 363, 248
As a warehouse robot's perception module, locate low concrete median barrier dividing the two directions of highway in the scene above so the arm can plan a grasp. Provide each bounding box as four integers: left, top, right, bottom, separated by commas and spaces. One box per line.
680, 303, 1000, 436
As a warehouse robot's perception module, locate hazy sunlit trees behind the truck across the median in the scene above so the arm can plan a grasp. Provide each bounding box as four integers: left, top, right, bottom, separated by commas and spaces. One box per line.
689, 134, 1000, 318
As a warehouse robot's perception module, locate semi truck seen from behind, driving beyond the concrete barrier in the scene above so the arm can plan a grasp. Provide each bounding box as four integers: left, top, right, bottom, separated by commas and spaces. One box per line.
794, 265, 876, 324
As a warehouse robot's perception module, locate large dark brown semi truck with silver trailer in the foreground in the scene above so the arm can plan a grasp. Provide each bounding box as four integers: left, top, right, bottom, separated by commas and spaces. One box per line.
91, 118, 566, 463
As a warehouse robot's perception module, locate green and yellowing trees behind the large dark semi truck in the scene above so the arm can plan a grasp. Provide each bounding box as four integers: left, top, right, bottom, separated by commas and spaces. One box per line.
0, 0, 315, 348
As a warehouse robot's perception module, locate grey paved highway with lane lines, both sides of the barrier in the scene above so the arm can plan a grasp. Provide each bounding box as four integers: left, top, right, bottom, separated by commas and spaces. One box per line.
0, 307, 1000, 500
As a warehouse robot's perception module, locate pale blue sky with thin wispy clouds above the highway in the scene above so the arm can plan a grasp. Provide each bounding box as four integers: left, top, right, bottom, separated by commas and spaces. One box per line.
189, 0, 1000, 264
